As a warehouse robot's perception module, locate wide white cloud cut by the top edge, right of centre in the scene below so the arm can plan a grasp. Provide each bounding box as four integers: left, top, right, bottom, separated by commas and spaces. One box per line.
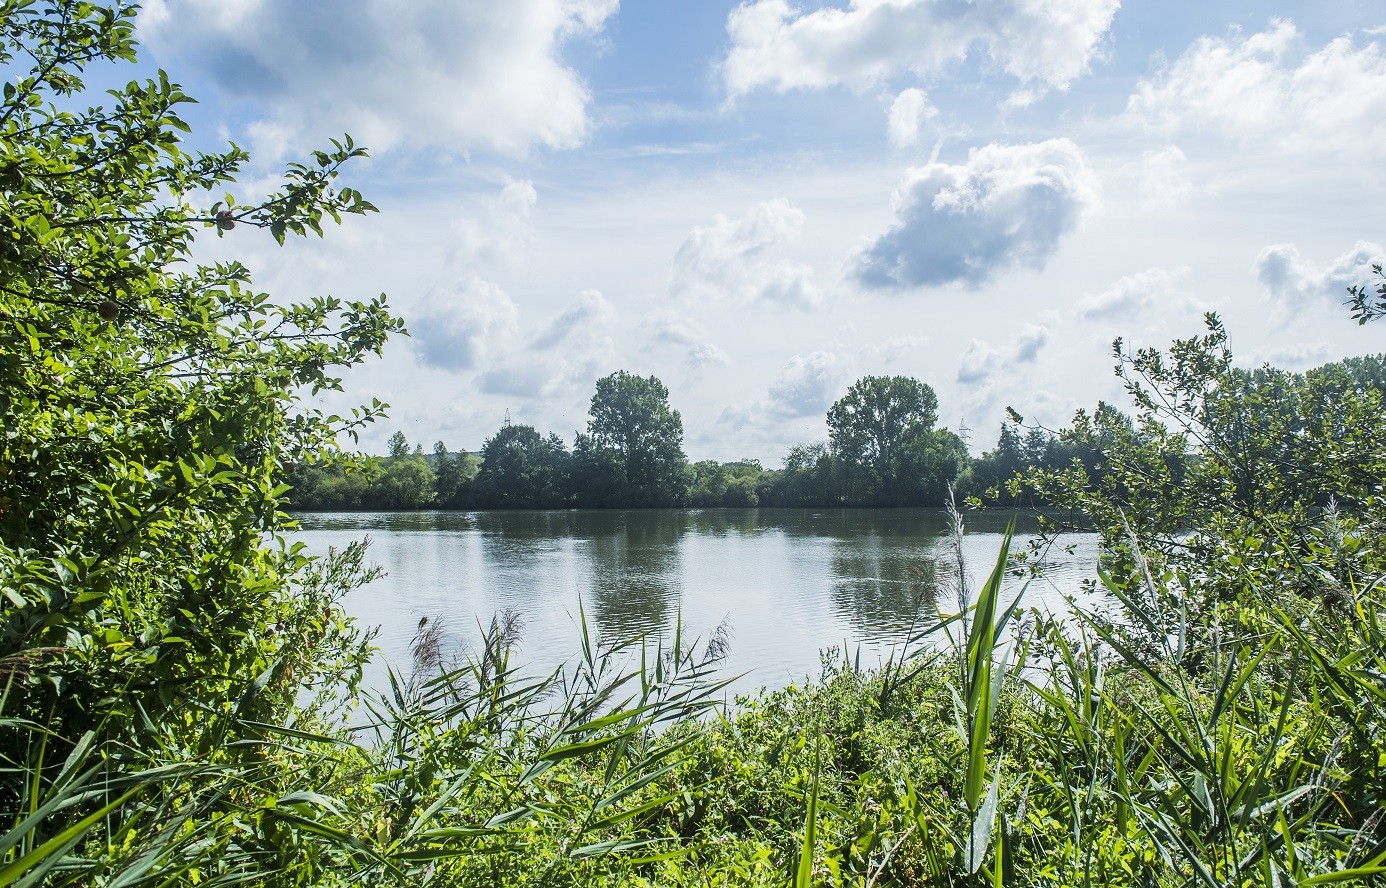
722, 0, 1120, 96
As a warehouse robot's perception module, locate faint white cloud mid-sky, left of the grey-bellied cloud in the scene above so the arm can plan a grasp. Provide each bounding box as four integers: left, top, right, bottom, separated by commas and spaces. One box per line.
669, 199, 821, 306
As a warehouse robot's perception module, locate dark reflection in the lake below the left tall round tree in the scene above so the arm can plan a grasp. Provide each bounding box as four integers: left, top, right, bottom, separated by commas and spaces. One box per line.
588, 511, 687, 641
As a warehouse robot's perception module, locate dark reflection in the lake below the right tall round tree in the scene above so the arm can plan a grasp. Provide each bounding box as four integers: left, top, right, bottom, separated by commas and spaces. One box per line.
833, 536, 938, 641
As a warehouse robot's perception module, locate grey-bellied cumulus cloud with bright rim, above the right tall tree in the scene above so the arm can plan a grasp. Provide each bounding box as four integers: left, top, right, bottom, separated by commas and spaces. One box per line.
852, 139, 1098, 288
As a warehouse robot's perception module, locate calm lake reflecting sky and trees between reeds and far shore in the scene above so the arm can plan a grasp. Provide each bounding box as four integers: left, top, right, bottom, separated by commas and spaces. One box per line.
291, 508, 1096, 693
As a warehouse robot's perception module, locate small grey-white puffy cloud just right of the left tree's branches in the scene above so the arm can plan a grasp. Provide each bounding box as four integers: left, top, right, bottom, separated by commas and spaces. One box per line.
409, 277, 517, 371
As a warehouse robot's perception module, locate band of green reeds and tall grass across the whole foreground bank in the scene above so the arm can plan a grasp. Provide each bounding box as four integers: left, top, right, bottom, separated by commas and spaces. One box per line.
10, 517, 1386, 888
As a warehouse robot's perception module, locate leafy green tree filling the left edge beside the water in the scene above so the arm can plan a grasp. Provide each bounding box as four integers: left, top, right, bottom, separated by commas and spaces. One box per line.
0, 0, 402, 748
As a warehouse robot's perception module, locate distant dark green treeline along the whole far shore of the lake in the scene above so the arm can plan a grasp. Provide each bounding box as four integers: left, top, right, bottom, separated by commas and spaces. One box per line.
290, 349, 1386, 511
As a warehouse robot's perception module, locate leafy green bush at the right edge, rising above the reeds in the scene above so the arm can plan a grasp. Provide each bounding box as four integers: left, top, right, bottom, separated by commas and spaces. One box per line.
1026, 314, 1386, 596
